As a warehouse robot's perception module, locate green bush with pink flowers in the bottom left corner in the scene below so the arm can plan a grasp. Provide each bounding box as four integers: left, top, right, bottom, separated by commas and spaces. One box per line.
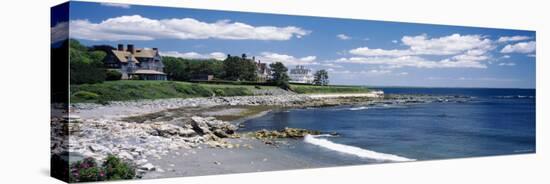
70, 155, 136, 182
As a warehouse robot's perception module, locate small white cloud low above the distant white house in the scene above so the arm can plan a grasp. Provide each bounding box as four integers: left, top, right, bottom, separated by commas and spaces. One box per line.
256, 52, 319, 65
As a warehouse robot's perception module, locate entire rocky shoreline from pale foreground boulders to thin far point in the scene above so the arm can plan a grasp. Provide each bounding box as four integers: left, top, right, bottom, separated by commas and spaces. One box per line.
52, 93, 469, 176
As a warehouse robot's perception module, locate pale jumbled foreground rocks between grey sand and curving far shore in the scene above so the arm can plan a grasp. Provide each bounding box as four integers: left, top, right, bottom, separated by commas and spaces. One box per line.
52, 116, 237, 176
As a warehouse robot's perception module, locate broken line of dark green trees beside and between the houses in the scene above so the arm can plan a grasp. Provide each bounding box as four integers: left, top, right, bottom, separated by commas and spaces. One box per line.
69, 39, 328, 89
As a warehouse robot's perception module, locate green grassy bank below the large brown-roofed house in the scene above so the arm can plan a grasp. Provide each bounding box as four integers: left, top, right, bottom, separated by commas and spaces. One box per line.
70, 80, 267, 103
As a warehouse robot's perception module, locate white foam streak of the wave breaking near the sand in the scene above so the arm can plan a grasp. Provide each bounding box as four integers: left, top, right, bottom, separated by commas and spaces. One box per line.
304, 135, 415, 162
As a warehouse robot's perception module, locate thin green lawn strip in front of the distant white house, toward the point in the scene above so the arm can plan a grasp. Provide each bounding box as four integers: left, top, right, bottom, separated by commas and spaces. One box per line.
290, 84, 369, 94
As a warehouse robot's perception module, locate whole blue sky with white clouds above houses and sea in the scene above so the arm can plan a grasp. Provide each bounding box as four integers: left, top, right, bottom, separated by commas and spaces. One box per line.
51, 2, 536, 88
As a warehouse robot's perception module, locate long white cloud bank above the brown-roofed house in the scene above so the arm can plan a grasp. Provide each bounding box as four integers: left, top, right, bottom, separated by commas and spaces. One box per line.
70, 15, 311, 41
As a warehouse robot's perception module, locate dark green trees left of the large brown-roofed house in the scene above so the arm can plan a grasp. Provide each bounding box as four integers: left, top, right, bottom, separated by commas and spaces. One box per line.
69, 40, 106, 84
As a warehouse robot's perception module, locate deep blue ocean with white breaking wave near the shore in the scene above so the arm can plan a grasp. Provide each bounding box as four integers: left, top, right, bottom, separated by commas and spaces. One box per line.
240, 88, 536, 165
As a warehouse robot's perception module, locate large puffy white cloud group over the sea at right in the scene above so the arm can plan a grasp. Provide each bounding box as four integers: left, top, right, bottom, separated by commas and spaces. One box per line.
344, 34, 495, 68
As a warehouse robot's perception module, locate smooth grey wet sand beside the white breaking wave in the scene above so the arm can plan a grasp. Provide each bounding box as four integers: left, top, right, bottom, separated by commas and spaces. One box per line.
139, 138, 343, 179
